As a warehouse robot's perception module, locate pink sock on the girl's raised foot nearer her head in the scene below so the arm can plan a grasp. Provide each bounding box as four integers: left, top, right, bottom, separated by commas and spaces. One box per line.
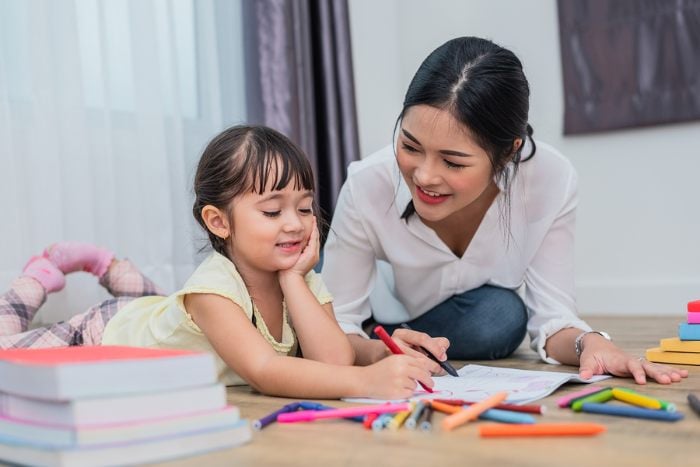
44, 242, 114, 277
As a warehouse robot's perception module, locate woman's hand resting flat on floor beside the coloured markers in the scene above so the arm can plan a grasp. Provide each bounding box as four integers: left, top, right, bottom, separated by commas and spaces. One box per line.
579, 334, 688, 384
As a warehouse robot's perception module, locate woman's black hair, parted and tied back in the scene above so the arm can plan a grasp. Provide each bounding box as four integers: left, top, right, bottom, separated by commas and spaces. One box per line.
394, 37, 536, 219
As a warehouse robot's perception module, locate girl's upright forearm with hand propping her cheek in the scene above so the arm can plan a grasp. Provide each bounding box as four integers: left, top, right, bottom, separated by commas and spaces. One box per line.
278, 222, 355, 365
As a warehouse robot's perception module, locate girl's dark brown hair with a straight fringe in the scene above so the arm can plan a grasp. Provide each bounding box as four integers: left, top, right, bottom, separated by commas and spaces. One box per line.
192, 125, 315, 259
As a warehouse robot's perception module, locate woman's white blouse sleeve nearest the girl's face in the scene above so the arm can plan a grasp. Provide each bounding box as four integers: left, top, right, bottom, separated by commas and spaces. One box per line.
321, 180, 376, 337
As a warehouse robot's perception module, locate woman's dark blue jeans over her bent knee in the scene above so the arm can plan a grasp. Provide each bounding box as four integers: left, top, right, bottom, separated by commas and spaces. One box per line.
372, 285, 527, 360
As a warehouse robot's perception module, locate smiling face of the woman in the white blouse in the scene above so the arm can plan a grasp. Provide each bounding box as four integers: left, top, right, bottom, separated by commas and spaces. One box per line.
396, 105, 494, 222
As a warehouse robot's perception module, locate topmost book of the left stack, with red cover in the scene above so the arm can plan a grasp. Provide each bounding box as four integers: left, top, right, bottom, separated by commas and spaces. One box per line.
0, 345, 217, 400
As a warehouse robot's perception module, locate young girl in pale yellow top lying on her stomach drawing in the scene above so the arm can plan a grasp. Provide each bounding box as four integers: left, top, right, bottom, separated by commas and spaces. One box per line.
0, 126, 438, 398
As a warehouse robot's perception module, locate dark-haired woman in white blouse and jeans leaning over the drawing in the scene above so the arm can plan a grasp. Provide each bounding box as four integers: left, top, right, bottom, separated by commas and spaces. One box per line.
323, 37, 687, 384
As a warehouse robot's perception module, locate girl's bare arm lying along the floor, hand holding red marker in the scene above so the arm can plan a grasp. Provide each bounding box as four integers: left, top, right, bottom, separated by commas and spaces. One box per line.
185, 294, 433, 399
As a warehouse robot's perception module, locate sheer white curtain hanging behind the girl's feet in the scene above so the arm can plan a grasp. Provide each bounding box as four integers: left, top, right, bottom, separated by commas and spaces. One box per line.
0, 0, 246, 322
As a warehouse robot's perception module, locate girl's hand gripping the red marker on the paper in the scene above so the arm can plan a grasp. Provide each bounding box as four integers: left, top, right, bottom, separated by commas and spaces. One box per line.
361, 355, 434, 399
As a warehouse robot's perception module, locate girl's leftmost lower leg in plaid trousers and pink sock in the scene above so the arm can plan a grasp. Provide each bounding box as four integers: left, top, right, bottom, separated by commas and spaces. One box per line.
0, 256, 65, 336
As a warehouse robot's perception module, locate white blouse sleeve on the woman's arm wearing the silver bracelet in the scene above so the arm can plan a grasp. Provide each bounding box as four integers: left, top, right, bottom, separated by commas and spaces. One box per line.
524, 166, 591, 363
